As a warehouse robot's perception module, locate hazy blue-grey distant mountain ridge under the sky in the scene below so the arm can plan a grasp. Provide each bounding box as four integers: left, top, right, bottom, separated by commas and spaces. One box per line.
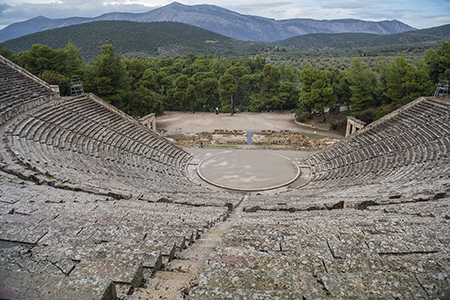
0, 2, 415, 42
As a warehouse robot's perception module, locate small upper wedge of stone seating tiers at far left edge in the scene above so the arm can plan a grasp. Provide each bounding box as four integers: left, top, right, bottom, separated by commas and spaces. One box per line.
0, 55, 59, 125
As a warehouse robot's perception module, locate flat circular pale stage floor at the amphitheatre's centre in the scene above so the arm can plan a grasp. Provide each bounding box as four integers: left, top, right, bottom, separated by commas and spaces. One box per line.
197, 151, 301, 191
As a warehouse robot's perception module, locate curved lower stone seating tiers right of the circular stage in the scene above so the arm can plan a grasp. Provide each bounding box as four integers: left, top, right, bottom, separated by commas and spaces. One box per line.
247, 98, 450, 210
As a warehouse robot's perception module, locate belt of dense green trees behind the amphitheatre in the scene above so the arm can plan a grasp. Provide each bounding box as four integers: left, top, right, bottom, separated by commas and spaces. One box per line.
0, 42, 450, 127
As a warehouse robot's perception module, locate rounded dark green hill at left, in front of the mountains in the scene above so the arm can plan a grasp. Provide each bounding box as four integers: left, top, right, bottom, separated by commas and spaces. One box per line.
4, 21, 261, 61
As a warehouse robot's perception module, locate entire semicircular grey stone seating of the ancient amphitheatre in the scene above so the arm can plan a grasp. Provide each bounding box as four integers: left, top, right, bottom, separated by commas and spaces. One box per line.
0, 53, 450, 299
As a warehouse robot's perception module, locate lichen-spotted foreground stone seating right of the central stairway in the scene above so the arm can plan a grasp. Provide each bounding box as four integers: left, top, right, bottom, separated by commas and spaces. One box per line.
190, 203, 450, 299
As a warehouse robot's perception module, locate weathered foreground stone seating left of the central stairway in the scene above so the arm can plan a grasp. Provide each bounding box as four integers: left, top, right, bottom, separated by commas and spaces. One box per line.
0, 172, 228, 299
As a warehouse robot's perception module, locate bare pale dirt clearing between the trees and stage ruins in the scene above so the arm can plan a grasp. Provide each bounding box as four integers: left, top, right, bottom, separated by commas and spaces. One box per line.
156, 111, 342, 138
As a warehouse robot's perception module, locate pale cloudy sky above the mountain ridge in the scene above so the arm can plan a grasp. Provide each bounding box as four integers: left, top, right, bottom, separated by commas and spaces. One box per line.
0, 0, 450, 29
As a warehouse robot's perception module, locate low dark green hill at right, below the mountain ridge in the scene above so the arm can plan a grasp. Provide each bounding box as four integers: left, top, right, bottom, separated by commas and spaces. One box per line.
274, 25, 450, 50
